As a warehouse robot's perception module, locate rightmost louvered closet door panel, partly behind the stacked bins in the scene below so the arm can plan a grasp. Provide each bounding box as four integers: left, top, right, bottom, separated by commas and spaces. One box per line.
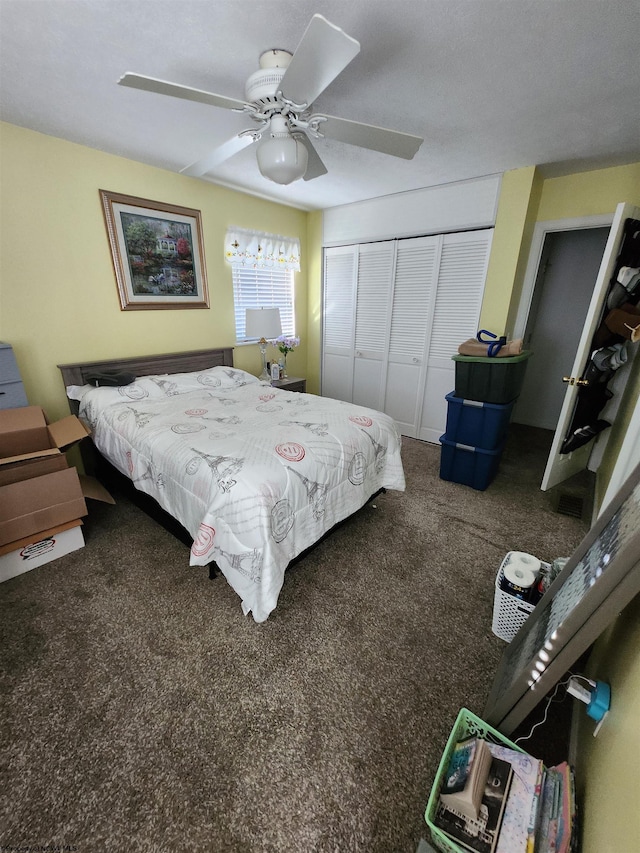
419, 229, 493, 442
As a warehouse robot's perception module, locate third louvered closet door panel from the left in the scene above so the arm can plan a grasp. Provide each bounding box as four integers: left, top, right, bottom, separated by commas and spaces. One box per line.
384, 237, 439, 438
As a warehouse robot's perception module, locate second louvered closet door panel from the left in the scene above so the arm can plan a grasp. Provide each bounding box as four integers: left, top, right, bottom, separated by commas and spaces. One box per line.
353, 240, 395, 409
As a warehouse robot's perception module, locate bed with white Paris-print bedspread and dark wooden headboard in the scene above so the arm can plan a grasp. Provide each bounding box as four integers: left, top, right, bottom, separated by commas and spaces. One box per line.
59, 348, 405, 622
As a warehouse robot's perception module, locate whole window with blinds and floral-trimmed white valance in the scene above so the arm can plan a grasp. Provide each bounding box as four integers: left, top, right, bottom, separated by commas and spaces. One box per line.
225, 228, 300, 343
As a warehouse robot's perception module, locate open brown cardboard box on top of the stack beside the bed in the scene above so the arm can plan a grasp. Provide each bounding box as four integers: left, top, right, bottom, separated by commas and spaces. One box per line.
0, 406, 90, 485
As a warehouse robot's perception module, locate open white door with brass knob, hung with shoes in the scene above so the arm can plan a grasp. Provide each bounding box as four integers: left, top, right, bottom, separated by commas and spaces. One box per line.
540, 203, 640, 491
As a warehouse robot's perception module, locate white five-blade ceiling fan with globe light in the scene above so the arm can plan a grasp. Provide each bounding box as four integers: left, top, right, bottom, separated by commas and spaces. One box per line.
118, 15, 423, 184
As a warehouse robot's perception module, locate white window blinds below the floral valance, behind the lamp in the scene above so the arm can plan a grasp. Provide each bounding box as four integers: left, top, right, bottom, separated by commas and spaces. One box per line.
233, 266, 296, 343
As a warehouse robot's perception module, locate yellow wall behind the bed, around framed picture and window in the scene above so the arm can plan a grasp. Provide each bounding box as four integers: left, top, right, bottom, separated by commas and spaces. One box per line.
0, 124, 309, 419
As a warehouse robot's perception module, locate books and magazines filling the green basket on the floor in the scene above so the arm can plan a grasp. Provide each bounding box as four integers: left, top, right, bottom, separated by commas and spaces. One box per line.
434, 737, 577, 853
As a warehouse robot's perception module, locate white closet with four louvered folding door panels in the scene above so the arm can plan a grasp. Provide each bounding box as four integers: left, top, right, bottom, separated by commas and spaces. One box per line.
322, 228, 493, 442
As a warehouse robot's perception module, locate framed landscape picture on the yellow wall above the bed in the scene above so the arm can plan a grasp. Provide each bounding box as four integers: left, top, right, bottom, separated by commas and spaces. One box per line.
100, 190, 209, 311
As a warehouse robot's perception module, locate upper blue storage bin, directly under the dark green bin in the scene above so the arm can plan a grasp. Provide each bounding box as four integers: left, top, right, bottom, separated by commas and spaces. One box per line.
445, 391, 515, 450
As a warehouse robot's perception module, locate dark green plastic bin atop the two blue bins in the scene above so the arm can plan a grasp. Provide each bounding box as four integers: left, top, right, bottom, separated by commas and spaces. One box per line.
452, 350, 533, 404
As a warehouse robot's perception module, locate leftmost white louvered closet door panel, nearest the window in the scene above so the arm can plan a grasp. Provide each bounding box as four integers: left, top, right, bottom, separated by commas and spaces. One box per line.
322, 246, 357, 402
